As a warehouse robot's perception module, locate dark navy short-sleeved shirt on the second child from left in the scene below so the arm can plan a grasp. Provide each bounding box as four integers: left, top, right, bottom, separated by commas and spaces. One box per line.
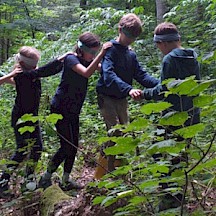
51, 55, 90, 118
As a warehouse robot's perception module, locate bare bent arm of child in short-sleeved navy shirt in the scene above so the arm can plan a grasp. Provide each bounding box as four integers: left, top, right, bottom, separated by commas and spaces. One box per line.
72, 42, 112, 78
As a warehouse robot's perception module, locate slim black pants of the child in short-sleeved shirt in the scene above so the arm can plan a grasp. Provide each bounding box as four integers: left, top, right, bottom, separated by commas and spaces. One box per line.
47, 108, 79, 173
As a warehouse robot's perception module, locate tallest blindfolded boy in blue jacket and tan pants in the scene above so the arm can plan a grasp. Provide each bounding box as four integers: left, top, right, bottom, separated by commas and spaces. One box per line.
96, 13, 158, 171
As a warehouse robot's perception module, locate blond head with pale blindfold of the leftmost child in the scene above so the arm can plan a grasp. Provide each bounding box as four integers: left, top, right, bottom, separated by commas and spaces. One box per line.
15, 46, 40, 70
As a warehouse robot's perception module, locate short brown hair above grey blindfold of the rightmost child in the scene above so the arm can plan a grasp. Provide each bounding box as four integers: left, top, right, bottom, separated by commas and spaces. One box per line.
154, 22, 179, 35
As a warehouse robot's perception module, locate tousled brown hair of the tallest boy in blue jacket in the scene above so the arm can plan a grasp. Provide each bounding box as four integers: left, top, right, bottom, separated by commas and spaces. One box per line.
119, 13, 142, 37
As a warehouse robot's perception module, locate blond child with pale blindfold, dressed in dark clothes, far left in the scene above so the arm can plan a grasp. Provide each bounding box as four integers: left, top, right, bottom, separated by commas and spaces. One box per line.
0, 46, 68, 198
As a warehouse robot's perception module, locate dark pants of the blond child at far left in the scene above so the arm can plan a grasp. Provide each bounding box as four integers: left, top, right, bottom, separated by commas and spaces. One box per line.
2, 122, 43, 179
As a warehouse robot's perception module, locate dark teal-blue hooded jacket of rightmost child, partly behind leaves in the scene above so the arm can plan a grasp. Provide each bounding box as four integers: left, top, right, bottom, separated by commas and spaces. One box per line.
143, 48, 200, 125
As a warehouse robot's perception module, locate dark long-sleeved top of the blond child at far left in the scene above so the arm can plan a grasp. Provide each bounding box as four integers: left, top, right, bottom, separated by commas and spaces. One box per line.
12, 60, 63, 127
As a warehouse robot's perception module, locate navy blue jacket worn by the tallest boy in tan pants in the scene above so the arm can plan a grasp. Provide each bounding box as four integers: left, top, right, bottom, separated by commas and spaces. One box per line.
96, 40, 158, 98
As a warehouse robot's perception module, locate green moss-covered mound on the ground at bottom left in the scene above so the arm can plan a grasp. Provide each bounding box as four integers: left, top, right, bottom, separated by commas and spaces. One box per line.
40, 185, 71, 216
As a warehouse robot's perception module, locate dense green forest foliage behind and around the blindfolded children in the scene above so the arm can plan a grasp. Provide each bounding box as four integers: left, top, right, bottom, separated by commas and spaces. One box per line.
0, 0, 216, 215
